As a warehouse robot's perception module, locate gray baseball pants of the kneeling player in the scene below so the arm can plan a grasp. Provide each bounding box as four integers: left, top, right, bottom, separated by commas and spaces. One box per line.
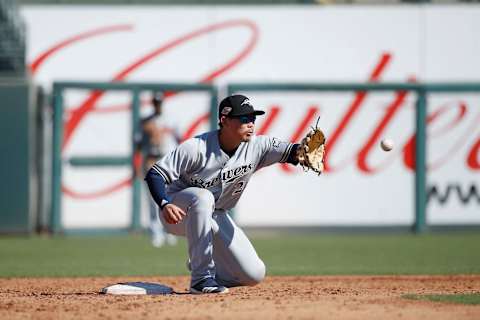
160, 187, 265, 287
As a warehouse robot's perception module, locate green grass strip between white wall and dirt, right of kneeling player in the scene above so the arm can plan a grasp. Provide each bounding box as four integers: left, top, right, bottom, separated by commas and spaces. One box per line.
255, 233, 480, 275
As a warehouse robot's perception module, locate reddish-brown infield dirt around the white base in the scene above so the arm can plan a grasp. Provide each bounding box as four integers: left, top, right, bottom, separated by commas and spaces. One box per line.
0, 275, 480, 320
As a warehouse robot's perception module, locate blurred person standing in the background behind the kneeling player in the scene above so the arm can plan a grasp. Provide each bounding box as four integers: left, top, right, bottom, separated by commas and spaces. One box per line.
137, 92, 177, 248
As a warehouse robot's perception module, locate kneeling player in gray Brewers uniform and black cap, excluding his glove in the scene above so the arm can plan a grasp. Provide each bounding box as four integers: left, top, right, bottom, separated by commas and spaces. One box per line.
145, 95, 299, 293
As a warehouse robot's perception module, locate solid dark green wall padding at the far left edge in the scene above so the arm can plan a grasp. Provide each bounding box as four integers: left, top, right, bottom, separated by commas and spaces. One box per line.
0, 77, 36, 233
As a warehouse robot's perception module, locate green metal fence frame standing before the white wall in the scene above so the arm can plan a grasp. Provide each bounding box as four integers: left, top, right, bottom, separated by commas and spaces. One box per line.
50, 82, 480, 233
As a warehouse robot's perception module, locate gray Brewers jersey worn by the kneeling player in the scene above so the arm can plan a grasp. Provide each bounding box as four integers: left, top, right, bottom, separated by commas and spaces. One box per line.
153, 130, 293, 210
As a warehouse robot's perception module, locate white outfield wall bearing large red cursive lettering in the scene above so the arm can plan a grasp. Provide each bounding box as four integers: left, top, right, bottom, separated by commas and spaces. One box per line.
22, 5, 480, 228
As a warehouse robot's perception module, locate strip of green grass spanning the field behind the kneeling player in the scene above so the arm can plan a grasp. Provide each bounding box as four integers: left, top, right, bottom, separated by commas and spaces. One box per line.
0, 233, 480, 277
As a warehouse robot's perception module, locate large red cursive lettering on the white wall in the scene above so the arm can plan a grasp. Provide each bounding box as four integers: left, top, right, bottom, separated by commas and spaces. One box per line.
30, 20, 480, 199
